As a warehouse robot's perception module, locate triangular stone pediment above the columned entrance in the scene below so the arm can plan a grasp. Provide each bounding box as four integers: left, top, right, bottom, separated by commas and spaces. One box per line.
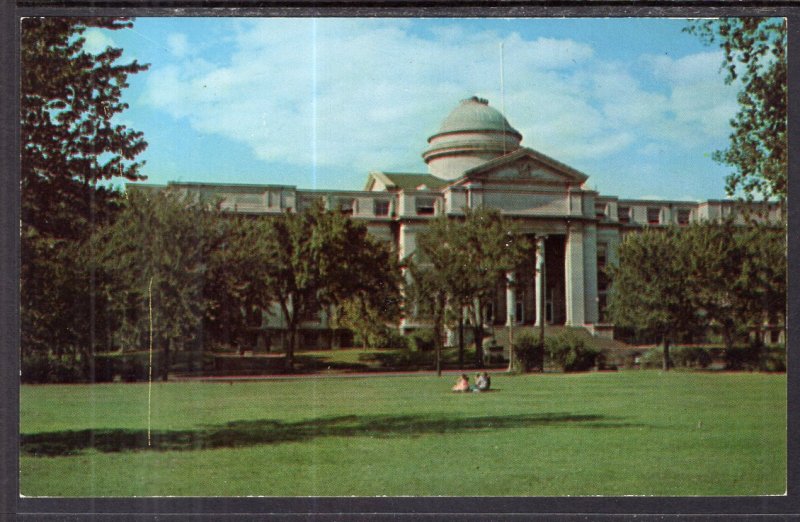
464, 148, 588, 185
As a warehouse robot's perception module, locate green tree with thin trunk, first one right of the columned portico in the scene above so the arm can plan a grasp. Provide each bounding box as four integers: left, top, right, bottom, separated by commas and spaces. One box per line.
609, 228, 699, 370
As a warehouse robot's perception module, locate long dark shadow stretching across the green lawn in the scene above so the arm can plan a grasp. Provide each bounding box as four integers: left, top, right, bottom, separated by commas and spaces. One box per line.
20, 413, 638, 456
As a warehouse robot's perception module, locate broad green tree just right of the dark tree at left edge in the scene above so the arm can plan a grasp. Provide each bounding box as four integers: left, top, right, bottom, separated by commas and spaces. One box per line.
93, 190, 222, 380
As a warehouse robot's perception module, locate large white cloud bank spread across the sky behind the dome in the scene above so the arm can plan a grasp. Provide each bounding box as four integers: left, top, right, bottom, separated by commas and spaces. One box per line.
144, 19, 735, 177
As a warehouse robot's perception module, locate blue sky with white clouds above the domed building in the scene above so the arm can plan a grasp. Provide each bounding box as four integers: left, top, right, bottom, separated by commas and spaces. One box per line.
86, 18, 736, 200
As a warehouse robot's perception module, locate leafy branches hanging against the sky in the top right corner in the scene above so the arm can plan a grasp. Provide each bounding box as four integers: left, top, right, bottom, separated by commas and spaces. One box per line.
685, 17, 788, 201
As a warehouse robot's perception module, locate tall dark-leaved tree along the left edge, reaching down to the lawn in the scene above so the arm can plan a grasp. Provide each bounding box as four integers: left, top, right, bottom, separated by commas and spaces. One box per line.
20, 17, 147, 374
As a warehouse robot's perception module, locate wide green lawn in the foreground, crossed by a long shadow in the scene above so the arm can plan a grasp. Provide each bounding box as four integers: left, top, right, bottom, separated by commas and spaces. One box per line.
20, 371, 786, 496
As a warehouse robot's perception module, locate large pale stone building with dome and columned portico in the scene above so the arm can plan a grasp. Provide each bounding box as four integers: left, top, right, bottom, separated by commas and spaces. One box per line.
138, 97, 780, 346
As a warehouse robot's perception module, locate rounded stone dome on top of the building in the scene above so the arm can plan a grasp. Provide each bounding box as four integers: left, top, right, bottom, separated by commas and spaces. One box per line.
422, 96, 522, 179
